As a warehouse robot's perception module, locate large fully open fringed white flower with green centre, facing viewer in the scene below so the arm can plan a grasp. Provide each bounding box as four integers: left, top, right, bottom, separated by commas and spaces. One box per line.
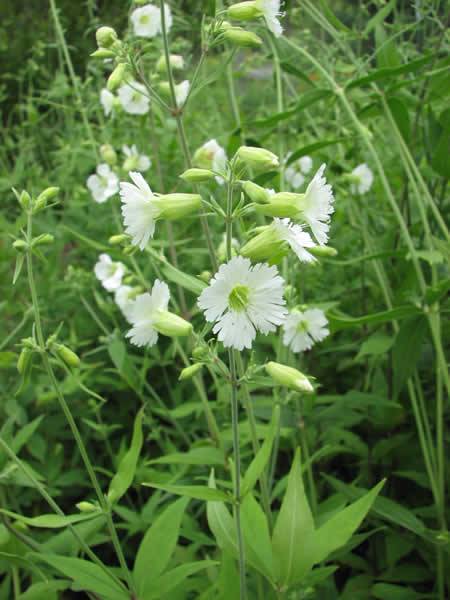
198, 256, 287, 350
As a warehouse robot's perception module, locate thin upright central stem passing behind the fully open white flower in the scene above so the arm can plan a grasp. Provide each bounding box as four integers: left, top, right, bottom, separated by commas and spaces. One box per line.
226, 171, 247, 600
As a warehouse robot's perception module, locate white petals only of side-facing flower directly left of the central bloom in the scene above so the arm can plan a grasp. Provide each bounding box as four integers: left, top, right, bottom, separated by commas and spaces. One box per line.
127, 279, 170, 346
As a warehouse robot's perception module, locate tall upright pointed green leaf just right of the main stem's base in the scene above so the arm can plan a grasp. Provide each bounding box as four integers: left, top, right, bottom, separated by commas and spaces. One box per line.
272, 450, 314, 585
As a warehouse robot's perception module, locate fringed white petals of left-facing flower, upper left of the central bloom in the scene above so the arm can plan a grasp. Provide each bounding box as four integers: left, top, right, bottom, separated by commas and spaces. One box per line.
120, 171, 158, 250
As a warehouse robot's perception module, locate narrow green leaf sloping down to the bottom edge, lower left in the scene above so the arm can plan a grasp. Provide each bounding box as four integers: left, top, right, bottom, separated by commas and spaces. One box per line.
30, 552, 129, 600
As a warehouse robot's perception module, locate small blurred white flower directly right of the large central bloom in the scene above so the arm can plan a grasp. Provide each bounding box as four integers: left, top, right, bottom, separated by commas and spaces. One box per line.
283, 308, 330, 352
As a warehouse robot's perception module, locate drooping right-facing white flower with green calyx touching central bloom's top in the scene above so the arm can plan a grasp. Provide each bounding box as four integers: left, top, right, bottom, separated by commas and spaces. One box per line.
240, 218, 316, 264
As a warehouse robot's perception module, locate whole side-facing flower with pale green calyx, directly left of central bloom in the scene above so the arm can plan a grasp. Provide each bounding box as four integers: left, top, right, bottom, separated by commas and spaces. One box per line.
127, 279, 192, 346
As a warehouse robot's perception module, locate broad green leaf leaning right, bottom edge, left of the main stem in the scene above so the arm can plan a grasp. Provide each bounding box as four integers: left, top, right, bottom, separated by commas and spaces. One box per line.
133, 498, 188, 597
